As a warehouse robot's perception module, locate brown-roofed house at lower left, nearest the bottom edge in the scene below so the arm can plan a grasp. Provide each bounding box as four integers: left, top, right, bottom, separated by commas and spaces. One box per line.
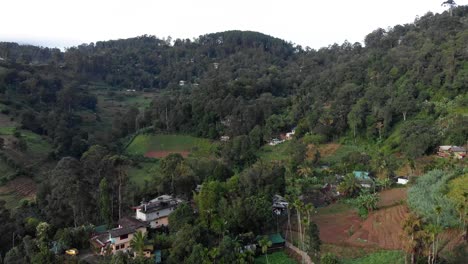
90, 217, 147, 255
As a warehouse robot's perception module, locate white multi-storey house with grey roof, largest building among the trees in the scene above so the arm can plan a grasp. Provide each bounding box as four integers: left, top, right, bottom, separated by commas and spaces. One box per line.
133, 195, 183, 228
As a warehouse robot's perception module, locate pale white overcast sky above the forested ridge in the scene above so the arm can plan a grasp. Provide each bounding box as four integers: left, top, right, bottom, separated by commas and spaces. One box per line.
0, 0, 468, 48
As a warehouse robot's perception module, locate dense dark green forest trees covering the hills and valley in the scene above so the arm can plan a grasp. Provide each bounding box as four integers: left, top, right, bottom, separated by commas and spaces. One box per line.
0, 3, 468, 263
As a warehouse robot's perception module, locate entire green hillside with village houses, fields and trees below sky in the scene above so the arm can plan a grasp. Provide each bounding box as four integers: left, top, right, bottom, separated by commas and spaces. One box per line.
0, 1, 468, 264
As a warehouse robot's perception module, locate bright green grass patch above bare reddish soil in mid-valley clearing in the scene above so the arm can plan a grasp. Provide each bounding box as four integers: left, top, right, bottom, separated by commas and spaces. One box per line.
127, 134, 216, 157
